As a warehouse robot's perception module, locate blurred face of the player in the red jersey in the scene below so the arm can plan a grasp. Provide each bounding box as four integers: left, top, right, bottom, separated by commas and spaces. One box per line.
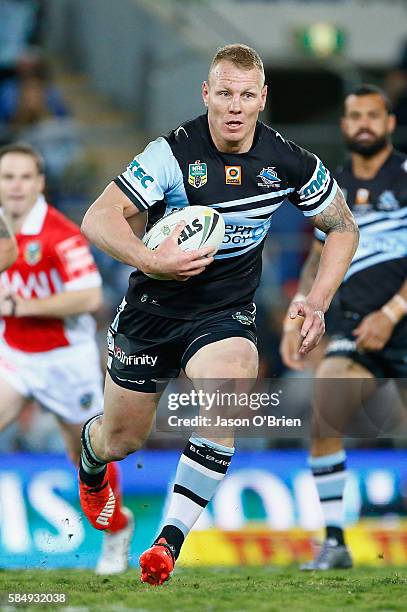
0, 153, 44, 219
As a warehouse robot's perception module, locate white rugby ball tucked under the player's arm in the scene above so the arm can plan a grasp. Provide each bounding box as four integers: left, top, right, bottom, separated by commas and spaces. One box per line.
142, 206, 225, 280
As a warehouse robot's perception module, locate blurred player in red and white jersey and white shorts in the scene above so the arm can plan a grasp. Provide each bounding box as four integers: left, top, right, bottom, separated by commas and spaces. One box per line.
0, 145, 134, 574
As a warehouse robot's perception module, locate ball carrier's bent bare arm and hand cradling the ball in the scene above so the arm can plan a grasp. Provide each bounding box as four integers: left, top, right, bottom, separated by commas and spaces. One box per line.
81, 183, 217, 280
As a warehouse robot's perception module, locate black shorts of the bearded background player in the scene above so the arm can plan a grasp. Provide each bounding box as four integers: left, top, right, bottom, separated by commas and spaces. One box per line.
325, 312, 407, 379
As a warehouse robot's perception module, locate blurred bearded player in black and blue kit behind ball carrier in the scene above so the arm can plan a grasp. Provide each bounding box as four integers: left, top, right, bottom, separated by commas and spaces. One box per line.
281, 85, 407, 570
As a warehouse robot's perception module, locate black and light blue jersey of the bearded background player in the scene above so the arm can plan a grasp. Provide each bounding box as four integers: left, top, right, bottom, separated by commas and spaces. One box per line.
315, 151, 407, 316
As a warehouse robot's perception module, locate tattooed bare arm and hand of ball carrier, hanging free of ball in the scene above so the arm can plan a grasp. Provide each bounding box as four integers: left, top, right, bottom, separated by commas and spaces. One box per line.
289, 189, 359, 355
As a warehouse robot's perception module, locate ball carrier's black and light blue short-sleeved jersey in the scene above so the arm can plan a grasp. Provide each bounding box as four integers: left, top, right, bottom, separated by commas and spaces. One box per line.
115, 115, 337, 319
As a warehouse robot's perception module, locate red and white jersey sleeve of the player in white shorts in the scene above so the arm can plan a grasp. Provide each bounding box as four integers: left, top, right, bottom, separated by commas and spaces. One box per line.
54, 231, 102, 291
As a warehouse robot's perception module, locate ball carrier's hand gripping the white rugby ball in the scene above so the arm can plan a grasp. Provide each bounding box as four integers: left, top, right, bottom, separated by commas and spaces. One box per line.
142, 222, 214, 281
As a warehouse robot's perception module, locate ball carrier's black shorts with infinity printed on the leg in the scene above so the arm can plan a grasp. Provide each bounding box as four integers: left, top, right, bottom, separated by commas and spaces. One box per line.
107, 300, 257, 393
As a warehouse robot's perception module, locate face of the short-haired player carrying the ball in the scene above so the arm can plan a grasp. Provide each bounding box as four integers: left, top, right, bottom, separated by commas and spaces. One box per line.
202, 61, 267, 153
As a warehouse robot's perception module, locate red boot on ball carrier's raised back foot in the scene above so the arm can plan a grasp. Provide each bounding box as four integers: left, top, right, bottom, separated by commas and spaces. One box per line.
79, 470, 117, 530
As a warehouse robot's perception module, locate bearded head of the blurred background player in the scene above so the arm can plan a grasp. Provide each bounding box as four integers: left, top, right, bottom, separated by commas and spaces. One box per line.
341, 94, 395, 158
